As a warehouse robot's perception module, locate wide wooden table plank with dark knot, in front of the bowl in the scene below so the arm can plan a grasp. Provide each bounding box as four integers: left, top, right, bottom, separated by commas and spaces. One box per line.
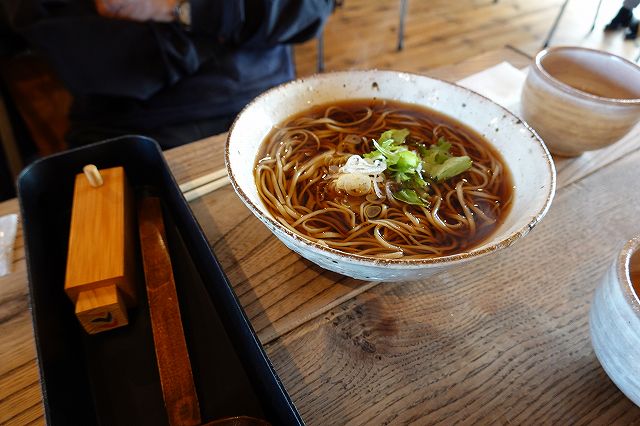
267, 151, 640, 424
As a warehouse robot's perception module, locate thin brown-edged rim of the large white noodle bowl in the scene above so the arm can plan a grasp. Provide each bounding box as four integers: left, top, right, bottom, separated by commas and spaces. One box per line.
224, 69, 556, 266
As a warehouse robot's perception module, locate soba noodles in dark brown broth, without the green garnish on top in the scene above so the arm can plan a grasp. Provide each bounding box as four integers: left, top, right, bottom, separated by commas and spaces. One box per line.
255, 100, 512, 258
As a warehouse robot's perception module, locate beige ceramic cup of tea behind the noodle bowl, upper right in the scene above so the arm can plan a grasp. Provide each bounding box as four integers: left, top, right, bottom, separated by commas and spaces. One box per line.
521, 46, 640, 156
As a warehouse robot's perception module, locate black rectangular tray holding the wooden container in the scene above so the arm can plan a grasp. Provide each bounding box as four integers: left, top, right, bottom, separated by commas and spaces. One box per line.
18, 136, 302, 425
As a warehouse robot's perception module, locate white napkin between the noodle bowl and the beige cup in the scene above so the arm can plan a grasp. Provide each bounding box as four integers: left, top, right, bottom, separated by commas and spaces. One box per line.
458, 62, 527, 115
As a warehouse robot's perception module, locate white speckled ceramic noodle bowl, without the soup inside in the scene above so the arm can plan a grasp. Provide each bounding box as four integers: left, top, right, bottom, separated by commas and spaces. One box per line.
225, 70, 556, 281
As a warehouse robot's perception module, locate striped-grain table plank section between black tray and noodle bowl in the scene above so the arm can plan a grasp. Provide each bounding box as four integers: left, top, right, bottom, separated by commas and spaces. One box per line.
185, 187, 372, 344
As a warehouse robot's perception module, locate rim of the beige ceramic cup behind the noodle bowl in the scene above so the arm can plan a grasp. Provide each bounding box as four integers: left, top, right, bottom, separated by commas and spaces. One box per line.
534, 46, 640, 105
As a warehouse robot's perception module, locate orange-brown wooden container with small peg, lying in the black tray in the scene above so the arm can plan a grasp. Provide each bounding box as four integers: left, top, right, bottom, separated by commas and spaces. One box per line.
64, 167, 137, 333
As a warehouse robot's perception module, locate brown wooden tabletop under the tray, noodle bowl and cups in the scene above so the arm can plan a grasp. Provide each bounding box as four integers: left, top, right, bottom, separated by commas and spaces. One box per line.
0, 48, 640, 425
